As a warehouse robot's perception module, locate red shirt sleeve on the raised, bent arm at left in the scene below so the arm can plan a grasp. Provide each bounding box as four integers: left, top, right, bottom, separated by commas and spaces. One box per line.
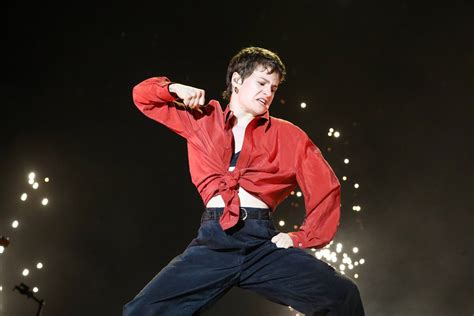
133, 77, 202, 139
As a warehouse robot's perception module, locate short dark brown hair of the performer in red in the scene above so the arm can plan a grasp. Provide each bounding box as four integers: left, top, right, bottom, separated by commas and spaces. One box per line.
222, 46, 286, 100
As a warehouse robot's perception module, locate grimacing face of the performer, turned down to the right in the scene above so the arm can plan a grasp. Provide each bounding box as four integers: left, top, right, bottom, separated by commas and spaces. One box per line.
233, 66, 280, 117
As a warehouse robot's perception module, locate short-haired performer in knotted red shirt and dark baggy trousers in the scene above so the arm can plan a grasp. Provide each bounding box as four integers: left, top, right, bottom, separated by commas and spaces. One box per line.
123, 47, 364, 316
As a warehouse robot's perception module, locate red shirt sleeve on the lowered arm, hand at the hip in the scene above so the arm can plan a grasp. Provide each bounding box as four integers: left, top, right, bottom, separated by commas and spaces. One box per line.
288, 134, 341, 248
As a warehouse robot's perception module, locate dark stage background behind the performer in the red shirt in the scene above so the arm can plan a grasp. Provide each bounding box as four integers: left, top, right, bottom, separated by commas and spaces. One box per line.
0, 0, 474, 316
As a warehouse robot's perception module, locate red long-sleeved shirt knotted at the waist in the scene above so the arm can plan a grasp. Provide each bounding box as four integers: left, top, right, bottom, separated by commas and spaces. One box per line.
133, 77, 340, 248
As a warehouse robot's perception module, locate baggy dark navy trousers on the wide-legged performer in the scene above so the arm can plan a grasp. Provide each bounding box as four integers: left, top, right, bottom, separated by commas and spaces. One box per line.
123, 207, 364, 316
